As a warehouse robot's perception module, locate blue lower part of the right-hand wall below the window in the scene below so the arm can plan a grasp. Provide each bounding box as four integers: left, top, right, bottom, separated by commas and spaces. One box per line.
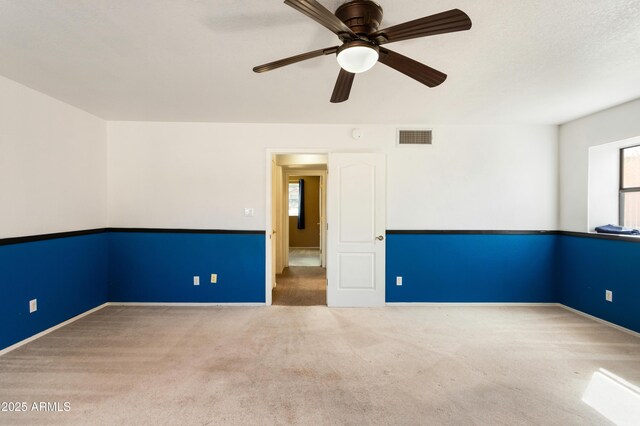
558, 236, 640, 332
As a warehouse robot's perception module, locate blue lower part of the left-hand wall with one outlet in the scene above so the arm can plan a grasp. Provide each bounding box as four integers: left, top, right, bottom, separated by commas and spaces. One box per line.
0, 233, 108, 349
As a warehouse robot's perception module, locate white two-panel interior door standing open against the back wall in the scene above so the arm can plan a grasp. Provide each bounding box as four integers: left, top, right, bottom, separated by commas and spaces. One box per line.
327, 154, 386, 307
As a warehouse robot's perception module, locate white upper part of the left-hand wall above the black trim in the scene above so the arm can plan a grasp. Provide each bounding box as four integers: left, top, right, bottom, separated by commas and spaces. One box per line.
0, 77, 107, 238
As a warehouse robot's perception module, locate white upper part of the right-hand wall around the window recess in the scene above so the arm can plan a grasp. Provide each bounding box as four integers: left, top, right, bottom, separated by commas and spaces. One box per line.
560, 100, 640, 232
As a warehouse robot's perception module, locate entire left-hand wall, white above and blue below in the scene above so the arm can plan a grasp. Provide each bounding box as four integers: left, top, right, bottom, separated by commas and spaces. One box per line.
0, 77, 108, 349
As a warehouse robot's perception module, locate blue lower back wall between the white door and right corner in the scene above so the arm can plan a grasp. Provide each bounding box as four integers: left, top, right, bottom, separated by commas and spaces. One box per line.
386, 234, 558, 302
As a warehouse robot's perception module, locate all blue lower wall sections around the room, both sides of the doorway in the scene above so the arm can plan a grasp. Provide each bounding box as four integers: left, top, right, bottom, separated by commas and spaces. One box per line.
0, 231, 640, 349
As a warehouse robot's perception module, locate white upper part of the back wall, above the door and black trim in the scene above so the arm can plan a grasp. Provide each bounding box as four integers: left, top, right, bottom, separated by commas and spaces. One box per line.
108, 122, 558, 230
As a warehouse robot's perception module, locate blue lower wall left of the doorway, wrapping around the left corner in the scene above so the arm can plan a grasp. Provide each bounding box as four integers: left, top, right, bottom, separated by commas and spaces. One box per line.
0, 229, 265, 350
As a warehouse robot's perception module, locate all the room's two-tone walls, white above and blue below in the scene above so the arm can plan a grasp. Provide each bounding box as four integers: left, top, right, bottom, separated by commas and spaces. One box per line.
0, 74, 640, 356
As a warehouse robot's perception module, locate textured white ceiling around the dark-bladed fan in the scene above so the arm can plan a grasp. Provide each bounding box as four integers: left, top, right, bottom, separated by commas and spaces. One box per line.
0, 0, 640, 124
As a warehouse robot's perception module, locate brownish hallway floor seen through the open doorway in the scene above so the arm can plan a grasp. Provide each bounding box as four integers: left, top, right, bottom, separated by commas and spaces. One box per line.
272, 266, 327, 306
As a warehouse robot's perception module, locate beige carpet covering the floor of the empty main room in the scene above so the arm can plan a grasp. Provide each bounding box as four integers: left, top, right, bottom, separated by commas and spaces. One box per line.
0, 306, 640, 425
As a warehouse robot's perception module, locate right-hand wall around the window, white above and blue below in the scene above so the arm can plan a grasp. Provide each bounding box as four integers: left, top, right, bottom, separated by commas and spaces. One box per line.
558, 100, 640, 332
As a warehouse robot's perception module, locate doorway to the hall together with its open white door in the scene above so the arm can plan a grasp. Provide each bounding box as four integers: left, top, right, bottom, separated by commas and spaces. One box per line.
265, 150, 386, 307
